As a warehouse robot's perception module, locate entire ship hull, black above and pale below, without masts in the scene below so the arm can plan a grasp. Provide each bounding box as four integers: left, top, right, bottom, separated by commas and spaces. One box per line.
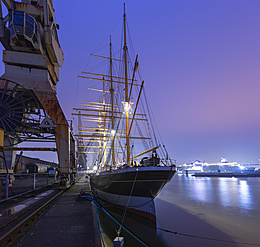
90, 166, 176, 221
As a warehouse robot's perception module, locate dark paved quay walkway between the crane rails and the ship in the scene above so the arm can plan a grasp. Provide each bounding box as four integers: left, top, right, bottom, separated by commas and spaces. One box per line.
15, 177, 101, 247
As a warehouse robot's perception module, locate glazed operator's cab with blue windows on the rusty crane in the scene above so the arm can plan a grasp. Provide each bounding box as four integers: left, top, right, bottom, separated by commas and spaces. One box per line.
9, 11, 37, 46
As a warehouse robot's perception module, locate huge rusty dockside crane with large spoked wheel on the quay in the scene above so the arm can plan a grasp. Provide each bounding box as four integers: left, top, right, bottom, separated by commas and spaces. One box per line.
0, 0, 76, 187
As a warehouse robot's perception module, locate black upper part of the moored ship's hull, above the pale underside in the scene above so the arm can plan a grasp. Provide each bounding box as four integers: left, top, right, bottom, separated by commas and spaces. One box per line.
90, 167, 175, 198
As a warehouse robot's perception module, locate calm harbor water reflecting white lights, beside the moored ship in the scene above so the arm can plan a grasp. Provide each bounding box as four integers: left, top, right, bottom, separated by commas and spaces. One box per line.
100, 174, 260, 247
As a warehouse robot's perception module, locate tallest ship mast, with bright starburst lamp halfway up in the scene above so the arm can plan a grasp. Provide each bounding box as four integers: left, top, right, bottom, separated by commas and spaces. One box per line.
124, 3, 130, 165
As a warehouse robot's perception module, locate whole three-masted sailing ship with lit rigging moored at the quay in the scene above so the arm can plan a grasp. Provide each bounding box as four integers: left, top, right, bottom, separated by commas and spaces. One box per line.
73, 6, 176, 221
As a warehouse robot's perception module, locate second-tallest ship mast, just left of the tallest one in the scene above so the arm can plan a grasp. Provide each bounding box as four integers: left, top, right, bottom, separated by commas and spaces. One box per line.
110, 36, 115, 166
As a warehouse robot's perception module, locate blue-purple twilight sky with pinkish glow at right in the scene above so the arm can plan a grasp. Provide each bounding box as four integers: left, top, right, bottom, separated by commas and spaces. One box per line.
0, 0, 260, 164
